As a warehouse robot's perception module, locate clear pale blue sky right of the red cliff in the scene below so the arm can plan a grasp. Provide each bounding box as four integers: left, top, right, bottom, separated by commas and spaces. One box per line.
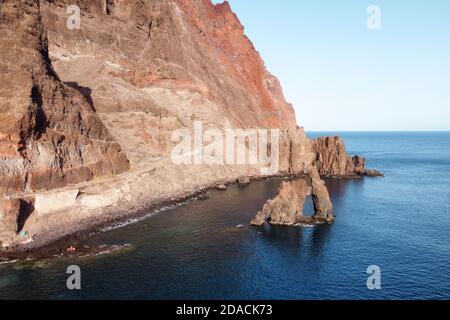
213, 0, 450, 131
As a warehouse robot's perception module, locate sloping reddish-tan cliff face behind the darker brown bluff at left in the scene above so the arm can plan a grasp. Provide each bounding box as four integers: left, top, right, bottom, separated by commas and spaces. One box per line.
37, 0, 297, 170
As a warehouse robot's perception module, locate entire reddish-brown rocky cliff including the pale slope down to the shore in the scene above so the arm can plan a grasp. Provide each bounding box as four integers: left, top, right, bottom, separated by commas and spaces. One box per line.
0, 0, 380, 250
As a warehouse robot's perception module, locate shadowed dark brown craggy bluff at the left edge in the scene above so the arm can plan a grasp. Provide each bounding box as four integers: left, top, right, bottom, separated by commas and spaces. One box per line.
0, 0, 128, 193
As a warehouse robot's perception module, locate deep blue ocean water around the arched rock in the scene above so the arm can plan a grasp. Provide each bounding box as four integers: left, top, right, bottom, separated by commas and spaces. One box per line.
0, 132, 450, 299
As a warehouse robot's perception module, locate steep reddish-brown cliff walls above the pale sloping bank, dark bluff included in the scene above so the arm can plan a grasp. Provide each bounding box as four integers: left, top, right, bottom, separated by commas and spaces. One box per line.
0, 0, 310, 193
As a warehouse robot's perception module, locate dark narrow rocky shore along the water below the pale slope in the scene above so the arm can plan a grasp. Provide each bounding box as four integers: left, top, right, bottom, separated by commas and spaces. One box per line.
0, 175, 287, 262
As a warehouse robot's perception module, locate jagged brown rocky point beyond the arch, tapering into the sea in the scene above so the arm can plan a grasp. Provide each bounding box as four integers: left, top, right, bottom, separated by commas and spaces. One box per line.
311, 137, 383, 178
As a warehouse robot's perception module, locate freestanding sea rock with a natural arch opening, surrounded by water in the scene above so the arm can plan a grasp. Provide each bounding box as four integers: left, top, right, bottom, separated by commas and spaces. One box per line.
251, 169, 335, 226
